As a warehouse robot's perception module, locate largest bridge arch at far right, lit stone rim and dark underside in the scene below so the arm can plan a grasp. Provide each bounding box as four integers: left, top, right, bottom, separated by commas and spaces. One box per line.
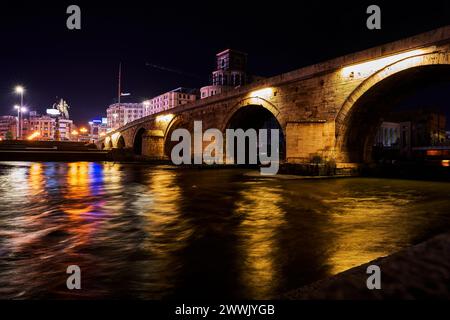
336, 52, 450, 163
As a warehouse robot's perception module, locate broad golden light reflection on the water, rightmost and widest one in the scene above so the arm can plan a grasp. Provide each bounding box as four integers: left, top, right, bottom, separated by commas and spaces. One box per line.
324, 197, 409, 275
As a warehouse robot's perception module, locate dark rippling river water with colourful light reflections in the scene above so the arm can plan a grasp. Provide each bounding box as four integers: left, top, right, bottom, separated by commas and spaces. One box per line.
0, 162, 450, 299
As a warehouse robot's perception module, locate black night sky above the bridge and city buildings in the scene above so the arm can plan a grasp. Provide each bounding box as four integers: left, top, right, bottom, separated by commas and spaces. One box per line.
0, 0, 450, 123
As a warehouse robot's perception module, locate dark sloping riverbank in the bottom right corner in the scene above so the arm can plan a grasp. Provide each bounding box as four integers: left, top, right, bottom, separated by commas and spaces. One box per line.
282, 233, 450, 300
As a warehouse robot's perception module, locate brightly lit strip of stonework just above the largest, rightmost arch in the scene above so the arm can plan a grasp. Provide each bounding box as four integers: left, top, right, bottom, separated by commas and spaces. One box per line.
342, 49, 429, 78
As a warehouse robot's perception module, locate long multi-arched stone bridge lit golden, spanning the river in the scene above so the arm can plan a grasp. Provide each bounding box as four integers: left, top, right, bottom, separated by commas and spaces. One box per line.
99, 26, 450, 168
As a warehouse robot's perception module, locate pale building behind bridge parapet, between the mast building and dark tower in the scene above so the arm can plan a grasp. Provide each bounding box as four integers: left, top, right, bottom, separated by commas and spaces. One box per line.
143, 87, 197, 116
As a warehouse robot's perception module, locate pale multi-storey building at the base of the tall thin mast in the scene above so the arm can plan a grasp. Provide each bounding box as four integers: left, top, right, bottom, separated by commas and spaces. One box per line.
106, 103, 144, 131
